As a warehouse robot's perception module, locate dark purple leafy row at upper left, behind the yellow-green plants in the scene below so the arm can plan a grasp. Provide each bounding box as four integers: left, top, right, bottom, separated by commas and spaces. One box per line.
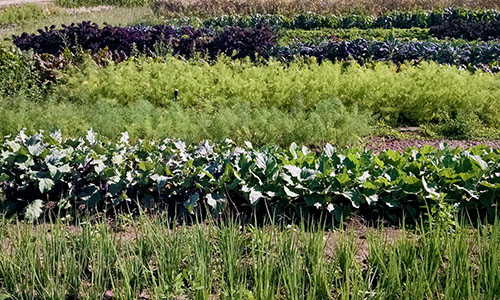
13, 22, 276, 59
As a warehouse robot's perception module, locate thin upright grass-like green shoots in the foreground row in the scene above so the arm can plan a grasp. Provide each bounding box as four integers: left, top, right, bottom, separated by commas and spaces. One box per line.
0, 216, 500, 300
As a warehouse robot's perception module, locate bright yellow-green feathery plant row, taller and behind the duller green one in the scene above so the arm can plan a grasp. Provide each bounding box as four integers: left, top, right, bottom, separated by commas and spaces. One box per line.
55, 57, 500, 128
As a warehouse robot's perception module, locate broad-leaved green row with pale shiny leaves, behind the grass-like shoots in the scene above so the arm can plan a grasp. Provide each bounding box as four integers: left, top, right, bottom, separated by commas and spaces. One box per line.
0, 130, 500, 220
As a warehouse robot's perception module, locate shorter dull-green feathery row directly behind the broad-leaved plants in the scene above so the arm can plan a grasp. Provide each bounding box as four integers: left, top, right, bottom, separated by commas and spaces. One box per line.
0, 95, 371, 146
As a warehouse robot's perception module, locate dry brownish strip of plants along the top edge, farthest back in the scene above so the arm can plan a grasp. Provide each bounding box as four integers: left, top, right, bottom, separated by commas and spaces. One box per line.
56, 0, 500, 15
